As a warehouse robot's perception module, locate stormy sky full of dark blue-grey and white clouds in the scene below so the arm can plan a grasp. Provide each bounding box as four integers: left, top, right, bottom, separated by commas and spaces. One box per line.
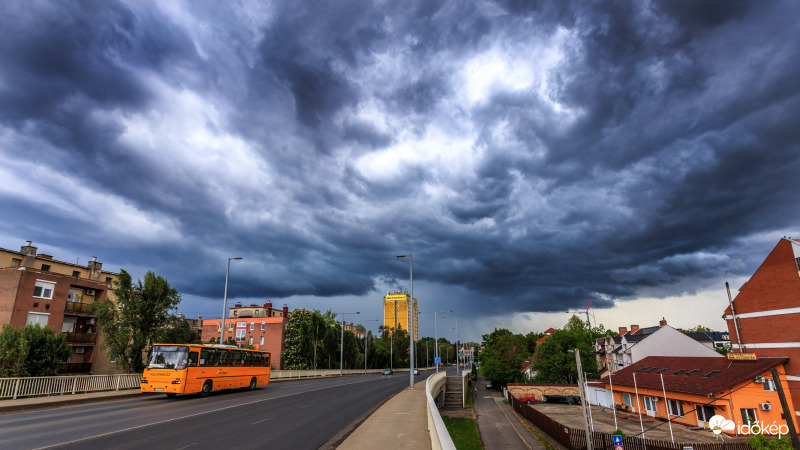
0, 0, 800, 339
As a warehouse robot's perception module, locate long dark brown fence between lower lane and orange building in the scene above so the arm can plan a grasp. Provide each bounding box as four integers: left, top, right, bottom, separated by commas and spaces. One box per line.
507, 393, 753, 450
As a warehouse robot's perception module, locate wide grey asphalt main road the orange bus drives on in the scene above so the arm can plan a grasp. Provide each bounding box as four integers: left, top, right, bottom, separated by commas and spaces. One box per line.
0, 372, 434, 450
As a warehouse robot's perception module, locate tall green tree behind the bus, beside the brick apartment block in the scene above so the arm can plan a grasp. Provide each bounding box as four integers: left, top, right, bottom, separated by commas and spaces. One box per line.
94, 269, 181, 373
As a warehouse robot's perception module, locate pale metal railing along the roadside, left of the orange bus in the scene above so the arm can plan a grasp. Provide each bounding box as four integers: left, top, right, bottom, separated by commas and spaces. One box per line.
0, 373, 142, 399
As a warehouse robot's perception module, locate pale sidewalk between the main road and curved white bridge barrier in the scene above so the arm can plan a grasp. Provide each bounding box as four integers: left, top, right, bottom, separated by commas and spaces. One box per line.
338, 381, 431, 450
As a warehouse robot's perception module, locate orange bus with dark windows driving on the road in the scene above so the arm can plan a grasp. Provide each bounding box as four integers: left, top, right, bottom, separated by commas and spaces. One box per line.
141, 344, 270, 397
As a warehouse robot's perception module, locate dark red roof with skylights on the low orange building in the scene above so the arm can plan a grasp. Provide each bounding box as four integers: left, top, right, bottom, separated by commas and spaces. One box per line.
606, 356, 789, 395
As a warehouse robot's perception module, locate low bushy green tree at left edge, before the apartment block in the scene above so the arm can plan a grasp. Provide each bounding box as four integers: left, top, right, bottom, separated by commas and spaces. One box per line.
0, 324, 70, 377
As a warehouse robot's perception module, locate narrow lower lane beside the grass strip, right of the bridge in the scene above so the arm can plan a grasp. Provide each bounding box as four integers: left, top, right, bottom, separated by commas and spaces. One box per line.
473, 377, 545, 450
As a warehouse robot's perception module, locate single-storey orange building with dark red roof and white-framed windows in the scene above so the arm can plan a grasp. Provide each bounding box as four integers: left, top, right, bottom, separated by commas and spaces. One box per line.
604, 356, 794, 434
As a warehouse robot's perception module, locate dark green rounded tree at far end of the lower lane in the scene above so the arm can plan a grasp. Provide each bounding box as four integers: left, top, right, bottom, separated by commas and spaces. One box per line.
480, 328, 528, 386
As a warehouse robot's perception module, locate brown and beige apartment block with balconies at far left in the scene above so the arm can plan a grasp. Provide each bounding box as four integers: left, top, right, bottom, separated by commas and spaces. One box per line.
0, 241, 117, 373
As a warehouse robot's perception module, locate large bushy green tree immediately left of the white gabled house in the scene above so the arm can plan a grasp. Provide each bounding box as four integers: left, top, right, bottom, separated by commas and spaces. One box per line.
531, 316, 605, 384
